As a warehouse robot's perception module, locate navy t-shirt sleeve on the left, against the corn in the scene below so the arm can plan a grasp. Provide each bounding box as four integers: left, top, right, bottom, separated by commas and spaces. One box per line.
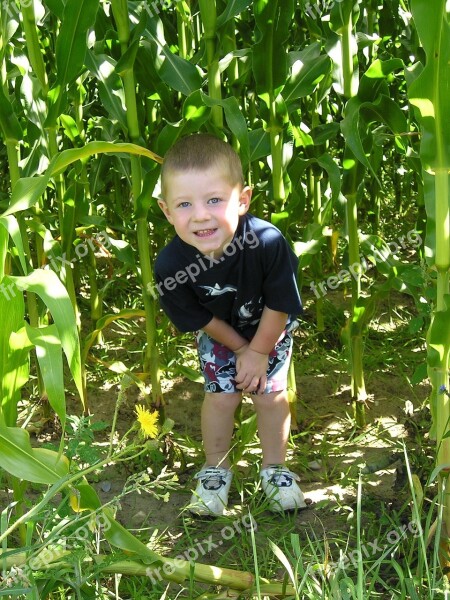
155, 251, 213, 332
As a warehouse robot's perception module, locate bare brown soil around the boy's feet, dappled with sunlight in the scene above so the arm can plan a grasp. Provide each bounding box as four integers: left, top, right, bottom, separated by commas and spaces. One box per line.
10, 288, 433, 584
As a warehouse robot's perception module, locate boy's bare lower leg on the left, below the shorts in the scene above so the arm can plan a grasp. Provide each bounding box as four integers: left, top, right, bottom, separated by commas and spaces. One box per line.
201, 392, 242, 469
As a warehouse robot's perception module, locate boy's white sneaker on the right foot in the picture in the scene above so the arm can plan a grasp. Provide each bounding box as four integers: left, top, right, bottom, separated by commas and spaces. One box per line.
259, 465, 306, 512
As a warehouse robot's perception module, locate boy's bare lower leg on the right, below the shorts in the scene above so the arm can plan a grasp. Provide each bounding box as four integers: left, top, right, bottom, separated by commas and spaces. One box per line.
252, 390, 291, 469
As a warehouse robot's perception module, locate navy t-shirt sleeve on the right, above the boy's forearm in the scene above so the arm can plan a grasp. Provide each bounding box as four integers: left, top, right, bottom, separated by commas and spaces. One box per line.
262, 228, 302, 316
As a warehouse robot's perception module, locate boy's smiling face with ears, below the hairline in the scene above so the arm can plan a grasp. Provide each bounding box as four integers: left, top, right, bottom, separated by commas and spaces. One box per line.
158, 165, 252, 258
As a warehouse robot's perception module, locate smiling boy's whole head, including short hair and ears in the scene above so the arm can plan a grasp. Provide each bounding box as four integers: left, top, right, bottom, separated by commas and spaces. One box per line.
158, 134, 252, 257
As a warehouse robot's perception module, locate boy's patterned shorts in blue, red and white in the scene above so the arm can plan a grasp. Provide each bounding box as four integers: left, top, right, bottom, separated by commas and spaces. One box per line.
197, 331, 292, 394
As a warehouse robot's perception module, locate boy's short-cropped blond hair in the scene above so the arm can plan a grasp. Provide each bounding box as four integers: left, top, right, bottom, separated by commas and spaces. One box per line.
161, 133, 244, 197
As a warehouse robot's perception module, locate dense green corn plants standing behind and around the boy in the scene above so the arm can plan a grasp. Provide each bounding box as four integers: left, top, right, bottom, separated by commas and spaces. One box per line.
0, 0, 442, 593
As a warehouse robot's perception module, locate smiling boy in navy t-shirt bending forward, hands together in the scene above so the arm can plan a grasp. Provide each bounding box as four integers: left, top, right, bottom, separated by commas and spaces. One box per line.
155, 134, 305, 515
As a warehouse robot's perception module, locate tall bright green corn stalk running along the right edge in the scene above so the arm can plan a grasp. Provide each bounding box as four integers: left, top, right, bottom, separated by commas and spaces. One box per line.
408, 0, 450, 561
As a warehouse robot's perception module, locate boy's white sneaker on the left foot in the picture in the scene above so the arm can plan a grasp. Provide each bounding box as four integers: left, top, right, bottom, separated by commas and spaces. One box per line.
188, 467, 233, 516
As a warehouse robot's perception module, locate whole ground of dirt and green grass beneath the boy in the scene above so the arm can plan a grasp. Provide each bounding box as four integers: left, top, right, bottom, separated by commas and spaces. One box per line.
0, 284, 448, 600
